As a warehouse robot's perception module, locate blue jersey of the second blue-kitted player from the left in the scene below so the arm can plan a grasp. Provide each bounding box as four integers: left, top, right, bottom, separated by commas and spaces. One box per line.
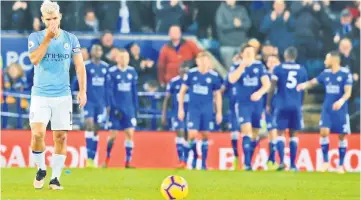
108, 65, 138, 113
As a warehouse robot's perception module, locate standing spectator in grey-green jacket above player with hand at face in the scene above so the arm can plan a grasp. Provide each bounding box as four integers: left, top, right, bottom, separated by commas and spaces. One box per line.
216, 0, 251, 69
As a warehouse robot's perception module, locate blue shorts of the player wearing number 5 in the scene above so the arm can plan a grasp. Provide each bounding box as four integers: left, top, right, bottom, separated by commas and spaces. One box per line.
274, 108, 303, 131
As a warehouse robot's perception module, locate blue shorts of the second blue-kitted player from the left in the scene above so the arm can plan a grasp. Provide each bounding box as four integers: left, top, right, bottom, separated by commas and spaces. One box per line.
108, 108, 137, 130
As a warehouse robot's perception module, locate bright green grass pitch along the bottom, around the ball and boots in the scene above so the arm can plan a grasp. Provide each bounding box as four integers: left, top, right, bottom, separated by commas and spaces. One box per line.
1, 168, 360, 200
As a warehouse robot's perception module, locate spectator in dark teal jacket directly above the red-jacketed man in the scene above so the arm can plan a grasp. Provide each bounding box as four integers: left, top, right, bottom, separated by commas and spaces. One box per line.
153, 0, 184, 33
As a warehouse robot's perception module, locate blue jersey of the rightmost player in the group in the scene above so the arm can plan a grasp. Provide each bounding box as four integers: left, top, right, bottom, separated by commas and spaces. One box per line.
316, 67, 352, 111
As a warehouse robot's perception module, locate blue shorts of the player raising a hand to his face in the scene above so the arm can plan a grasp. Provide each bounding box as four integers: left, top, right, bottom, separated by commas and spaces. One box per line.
235, 102, 263, 128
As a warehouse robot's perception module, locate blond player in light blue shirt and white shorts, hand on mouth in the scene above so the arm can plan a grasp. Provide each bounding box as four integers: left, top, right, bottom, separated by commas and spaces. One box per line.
28, 0, 86, 190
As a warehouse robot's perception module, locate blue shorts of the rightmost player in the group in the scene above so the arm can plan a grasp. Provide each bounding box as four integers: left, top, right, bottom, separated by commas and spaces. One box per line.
320, 109, 351, 134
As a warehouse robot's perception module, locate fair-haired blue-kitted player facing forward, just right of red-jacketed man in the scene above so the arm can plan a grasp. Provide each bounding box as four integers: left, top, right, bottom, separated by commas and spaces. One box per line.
178, 52, 222, 170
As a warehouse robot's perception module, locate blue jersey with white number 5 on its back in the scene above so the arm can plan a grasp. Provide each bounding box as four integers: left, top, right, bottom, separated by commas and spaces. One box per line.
272, 62, 308, 108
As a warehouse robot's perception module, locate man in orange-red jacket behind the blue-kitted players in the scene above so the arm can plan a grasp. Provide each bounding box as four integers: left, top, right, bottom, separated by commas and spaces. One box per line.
158, 26, 200, 87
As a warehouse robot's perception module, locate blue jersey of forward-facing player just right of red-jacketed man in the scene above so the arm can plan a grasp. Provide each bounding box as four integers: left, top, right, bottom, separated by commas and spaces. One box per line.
183, 68, 221, 109
